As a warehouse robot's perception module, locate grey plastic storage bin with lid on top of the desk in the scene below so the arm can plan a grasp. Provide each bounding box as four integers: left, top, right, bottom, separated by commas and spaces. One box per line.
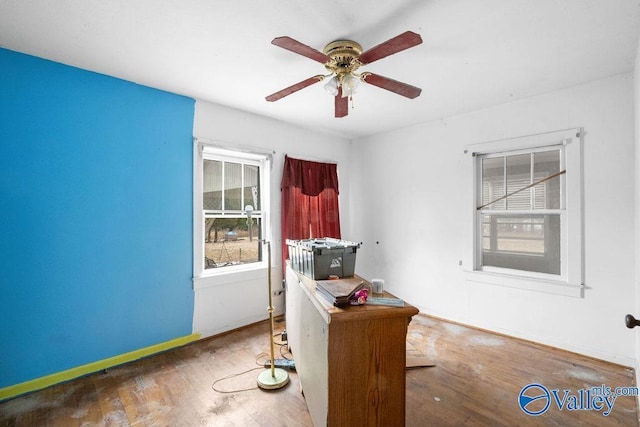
287, 237, 360, 280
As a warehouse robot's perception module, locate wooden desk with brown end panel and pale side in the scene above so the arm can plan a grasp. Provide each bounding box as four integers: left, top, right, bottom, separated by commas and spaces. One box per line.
286, 266, 418, 427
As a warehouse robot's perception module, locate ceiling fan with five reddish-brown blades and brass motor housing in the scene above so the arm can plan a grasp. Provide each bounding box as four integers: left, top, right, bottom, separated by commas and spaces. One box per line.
265, 31, 422, 117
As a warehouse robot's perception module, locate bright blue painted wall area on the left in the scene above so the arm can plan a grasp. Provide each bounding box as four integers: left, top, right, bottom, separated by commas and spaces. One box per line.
0, 49, 194, 388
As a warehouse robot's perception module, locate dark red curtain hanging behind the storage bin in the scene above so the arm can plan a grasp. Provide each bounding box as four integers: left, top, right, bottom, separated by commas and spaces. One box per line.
280, 155, 341, 269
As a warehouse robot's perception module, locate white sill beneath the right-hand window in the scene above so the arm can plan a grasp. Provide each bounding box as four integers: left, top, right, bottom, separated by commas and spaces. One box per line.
465, 270, 584, 298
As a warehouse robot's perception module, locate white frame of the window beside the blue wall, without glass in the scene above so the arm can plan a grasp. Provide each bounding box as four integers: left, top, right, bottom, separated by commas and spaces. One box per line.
193, 139, 272, 279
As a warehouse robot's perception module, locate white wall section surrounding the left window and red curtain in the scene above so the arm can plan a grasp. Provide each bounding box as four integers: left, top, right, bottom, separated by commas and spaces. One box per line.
193, 101, 350, 336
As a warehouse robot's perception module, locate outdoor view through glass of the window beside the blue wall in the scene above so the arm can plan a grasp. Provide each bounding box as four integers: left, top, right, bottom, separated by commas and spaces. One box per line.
203, 159, 262, 269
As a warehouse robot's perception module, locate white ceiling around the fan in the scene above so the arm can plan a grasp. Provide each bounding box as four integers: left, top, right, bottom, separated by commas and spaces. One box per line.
0, 0, 640, 138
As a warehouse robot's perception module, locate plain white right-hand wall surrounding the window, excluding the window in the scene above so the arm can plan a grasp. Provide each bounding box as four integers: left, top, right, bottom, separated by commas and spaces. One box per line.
344, 74, 637, 366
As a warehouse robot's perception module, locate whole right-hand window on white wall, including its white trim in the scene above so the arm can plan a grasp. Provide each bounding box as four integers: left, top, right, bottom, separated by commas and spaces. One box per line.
467, 129, 582, 296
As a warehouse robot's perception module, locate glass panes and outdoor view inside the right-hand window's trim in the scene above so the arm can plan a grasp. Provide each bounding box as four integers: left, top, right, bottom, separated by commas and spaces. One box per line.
479, 149, 562, 274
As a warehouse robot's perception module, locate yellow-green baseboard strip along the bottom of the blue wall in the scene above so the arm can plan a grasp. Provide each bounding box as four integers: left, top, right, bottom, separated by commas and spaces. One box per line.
0, 333, 201, 401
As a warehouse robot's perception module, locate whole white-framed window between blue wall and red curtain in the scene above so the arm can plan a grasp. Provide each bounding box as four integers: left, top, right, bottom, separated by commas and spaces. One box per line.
194, 145, 269, 276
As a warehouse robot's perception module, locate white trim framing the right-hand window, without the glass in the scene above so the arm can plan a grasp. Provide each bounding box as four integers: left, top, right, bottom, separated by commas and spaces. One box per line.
464, 128, 584, 297
